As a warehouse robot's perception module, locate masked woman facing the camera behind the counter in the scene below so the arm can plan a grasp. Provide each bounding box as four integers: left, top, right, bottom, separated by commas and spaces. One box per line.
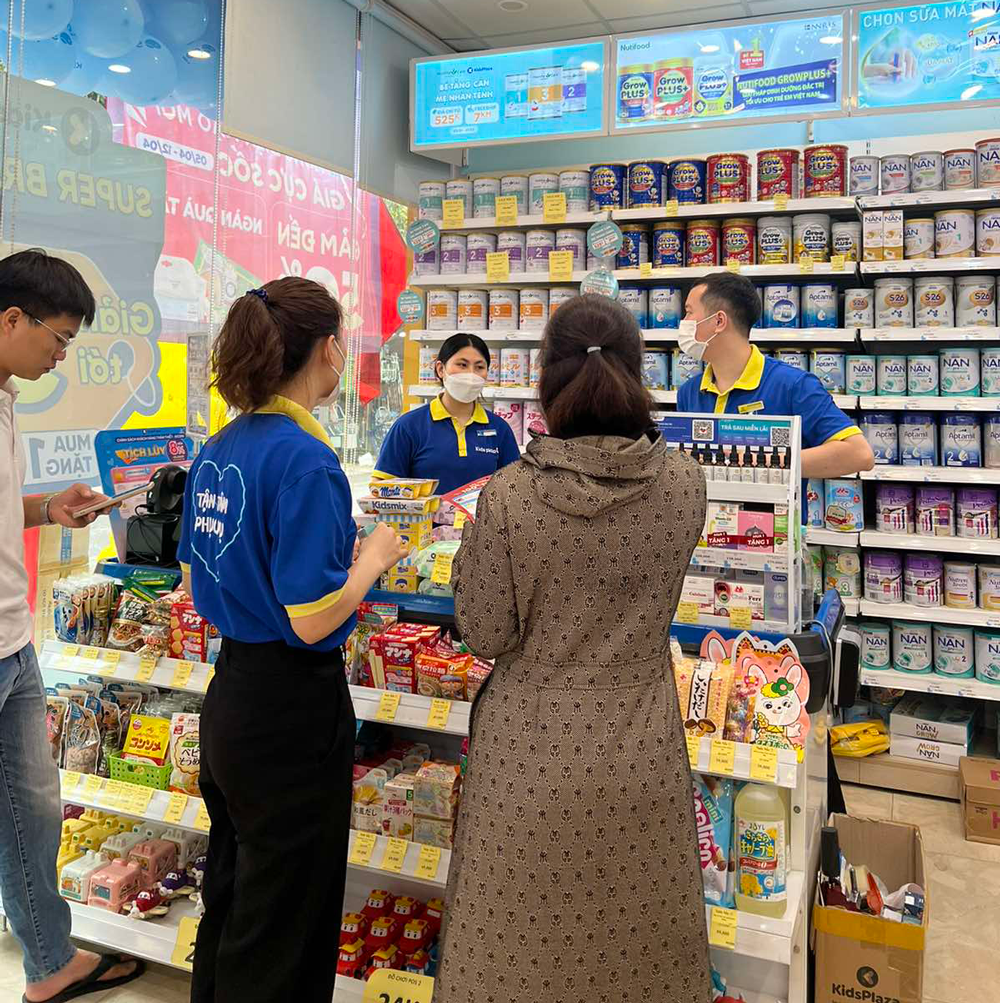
374, 334, 521, 494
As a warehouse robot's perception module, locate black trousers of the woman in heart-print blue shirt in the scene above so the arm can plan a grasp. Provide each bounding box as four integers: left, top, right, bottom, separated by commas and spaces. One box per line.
191, 638, 355, 1003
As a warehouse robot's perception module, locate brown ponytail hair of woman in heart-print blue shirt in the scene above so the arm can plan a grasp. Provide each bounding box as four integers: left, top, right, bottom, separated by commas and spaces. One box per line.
212, 276, 343, 414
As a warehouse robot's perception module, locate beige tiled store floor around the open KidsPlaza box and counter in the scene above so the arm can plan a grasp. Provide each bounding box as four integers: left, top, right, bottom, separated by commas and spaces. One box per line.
0, 787, 982, 1003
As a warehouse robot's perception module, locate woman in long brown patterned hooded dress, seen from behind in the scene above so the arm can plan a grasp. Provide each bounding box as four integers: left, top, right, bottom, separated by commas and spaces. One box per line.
434, 295, 711, 1003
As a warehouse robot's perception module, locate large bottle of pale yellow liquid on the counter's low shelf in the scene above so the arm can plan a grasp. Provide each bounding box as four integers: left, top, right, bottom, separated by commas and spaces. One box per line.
734, 783, 788, 917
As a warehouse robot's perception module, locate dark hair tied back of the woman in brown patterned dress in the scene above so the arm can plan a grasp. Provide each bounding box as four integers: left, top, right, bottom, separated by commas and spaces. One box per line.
539, 293, 653, 439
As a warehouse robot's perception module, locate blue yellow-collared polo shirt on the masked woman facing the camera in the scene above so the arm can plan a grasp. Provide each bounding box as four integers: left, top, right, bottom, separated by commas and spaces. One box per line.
374, 397, 521, 494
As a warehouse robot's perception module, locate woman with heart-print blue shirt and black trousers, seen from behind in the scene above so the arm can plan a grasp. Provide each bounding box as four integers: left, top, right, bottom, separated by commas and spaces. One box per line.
181, 278, 405, 1003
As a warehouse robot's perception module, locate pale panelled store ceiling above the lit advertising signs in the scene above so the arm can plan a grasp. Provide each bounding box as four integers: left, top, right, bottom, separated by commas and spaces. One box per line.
389, 0, 849, 50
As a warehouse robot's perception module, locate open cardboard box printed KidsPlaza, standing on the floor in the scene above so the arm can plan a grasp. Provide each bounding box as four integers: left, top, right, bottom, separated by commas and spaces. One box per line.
812, 814, 931, 1003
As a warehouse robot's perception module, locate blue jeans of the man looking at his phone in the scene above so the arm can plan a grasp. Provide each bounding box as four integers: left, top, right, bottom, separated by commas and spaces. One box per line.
0, 644, 75, 982
